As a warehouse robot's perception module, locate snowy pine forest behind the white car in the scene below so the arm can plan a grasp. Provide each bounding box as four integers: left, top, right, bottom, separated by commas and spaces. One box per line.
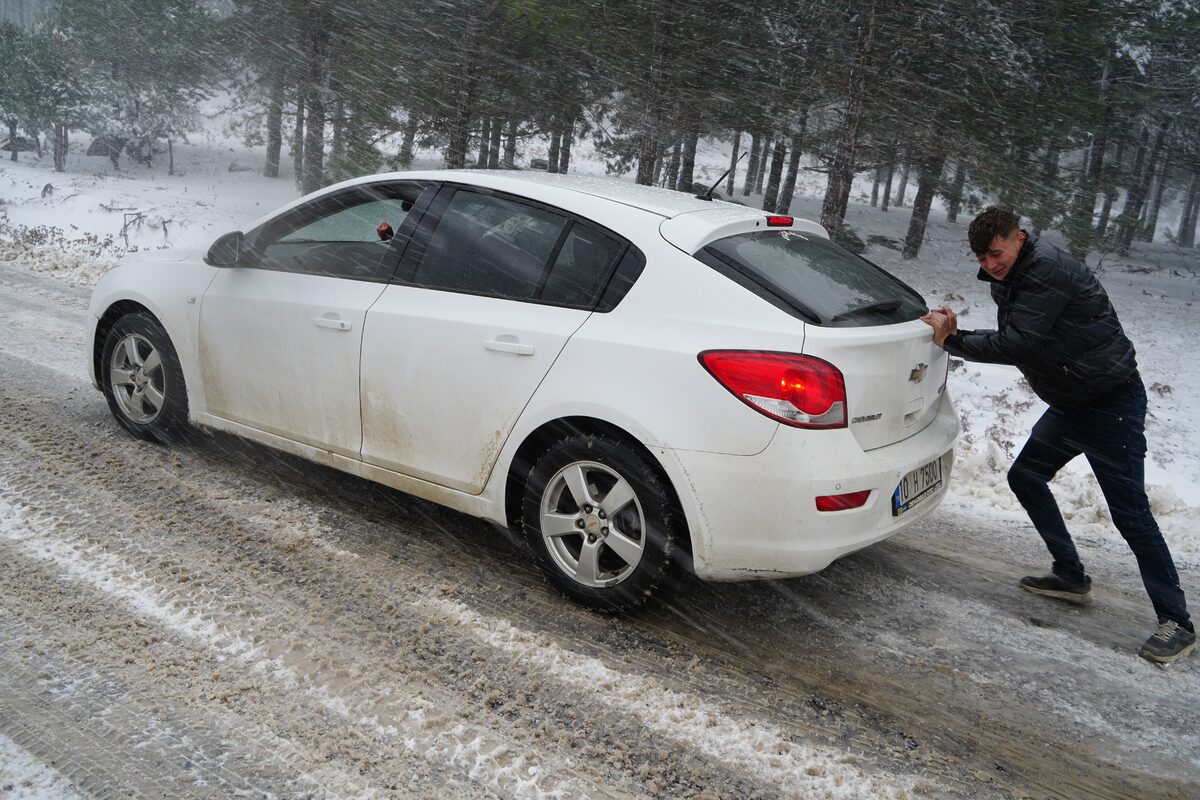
0, 0, 1200, 258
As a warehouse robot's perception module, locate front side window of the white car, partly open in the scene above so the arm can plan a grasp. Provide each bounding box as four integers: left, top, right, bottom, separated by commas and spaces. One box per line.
253, 184, 424, 281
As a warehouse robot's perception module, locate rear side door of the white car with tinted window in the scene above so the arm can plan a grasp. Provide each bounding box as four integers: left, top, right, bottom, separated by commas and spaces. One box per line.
362, 187, 625, 493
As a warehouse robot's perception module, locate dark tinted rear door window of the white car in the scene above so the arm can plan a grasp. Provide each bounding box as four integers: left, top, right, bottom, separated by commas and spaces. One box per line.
413, 190, 568, 300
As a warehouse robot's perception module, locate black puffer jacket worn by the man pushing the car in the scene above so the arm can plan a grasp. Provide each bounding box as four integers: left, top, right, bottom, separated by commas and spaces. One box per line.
944, 235, 1138, 408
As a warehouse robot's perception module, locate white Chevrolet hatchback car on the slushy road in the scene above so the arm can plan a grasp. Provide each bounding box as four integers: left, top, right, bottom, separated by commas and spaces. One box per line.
89, 170, 959, 608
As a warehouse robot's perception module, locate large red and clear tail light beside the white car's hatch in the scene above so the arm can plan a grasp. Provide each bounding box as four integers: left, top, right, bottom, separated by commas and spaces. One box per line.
698, 350, 846, 428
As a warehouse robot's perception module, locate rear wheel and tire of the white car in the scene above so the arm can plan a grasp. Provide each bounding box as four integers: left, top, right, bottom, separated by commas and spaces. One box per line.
521, 434, 682, 610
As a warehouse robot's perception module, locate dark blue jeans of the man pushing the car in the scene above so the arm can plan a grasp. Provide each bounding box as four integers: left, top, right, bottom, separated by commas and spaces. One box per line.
1008, 378, 1189, 627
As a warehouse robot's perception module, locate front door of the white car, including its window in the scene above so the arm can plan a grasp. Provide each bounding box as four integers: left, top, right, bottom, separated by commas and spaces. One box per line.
199, 184, 432, 458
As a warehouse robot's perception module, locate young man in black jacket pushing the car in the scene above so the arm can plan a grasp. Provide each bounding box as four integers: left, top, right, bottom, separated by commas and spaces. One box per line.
922, 205, 1196, 662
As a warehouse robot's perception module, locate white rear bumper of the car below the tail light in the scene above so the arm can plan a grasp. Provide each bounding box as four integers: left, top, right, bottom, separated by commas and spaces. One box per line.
673, 395, 959, 581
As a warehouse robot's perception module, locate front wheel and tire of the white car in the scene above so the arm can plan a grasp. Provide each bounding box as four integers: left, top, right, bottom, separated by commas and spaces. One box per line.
100, 312, 187, 443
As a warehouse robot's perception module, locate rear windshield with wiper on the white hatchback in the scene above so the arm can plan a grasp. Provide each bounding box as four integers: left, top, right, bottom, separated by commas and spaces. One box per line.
696, 230, 928, 327
